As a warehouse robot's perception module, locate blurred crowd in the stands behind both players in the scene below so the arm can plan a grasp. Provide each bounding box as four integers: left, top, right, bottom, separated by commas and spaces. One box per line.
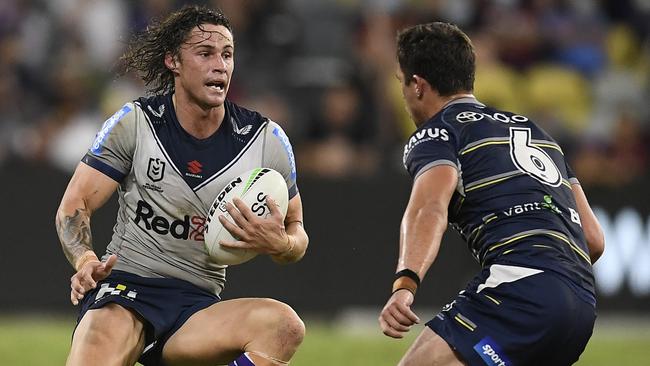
0, 0, 650, 186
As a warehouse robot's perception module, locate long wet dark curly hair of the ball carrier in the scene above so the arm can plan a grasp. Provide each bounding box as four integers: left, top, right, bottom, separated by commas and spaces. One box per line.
120, 5, 232, 94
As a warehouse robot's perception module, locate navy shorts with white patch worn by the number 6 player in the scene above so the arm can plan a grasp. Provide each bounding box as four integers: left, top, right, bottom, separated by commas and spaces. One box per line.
427, 265, 596, 366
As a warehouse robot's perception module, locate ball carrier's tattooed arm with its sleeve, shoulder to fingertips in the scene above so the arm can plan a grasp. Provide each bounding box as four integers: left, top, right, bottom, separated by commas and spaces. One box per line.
55, 103, 136, 305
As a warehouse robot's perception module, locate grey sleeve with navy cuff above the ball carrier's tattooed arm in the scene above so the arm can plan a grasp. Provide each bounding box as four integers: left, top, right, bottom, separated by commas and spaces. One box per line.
81, 103, 136, 182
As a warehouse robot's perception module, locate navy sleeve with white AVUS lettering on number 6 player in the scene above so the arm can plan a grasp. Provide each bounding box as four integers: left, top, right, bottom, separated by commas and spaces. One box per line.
404, 127, 460, 180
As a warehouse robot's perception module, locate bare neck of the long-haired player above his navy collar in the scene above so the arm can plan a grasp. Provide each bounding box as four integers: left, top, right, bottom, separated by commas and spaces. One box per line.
172, 93, 226, 139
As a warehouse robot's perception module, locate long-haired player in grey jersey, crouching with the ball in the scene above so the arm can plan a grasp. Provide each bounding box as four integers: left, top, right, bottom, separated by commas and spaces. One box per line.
56, 7, 308, 366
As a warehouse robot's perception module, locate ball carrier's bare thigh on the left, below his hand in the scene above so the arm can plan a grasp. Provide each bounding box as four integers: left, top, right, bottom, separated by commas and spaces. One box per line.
70, 303, 144, 363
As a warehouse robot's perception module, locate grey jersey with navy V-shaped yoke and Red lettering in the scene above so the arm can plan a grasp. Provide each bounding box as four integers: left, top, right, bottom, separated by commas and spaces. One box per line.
82, 95, 297, 294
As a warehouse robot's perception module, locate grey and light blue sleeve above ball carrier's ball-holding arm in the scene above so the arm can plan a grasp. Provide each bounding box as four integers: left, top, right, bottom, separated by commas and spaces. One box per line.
262, 121, 298, 199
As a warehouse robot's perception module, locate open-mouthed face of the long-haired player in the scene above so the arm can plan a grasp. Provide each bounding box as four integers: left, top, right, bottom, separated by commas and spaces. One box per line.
176, 24, 235, 108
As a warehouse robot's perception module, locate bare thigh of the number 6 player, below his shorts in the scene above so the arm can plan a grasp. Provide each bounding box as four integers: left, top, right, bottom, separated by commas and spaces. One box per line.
399, 327, 465, 366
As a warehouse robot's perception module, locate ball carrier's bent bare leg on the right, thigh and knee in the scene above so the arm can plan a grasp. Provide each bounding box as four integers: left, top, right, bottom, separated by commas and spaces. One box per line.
163, 298, 304, 362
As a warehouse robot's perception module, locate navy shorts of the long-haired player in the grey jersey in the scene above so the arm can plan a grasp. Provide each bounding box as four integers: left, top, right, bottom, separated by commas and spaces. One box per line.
77, 271, 219, 366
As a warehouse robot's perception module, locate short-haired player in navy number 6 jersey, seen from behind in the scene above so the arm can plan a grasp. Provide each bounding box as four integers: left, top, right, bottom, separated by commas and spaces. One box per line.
379, 23, 604, 366
